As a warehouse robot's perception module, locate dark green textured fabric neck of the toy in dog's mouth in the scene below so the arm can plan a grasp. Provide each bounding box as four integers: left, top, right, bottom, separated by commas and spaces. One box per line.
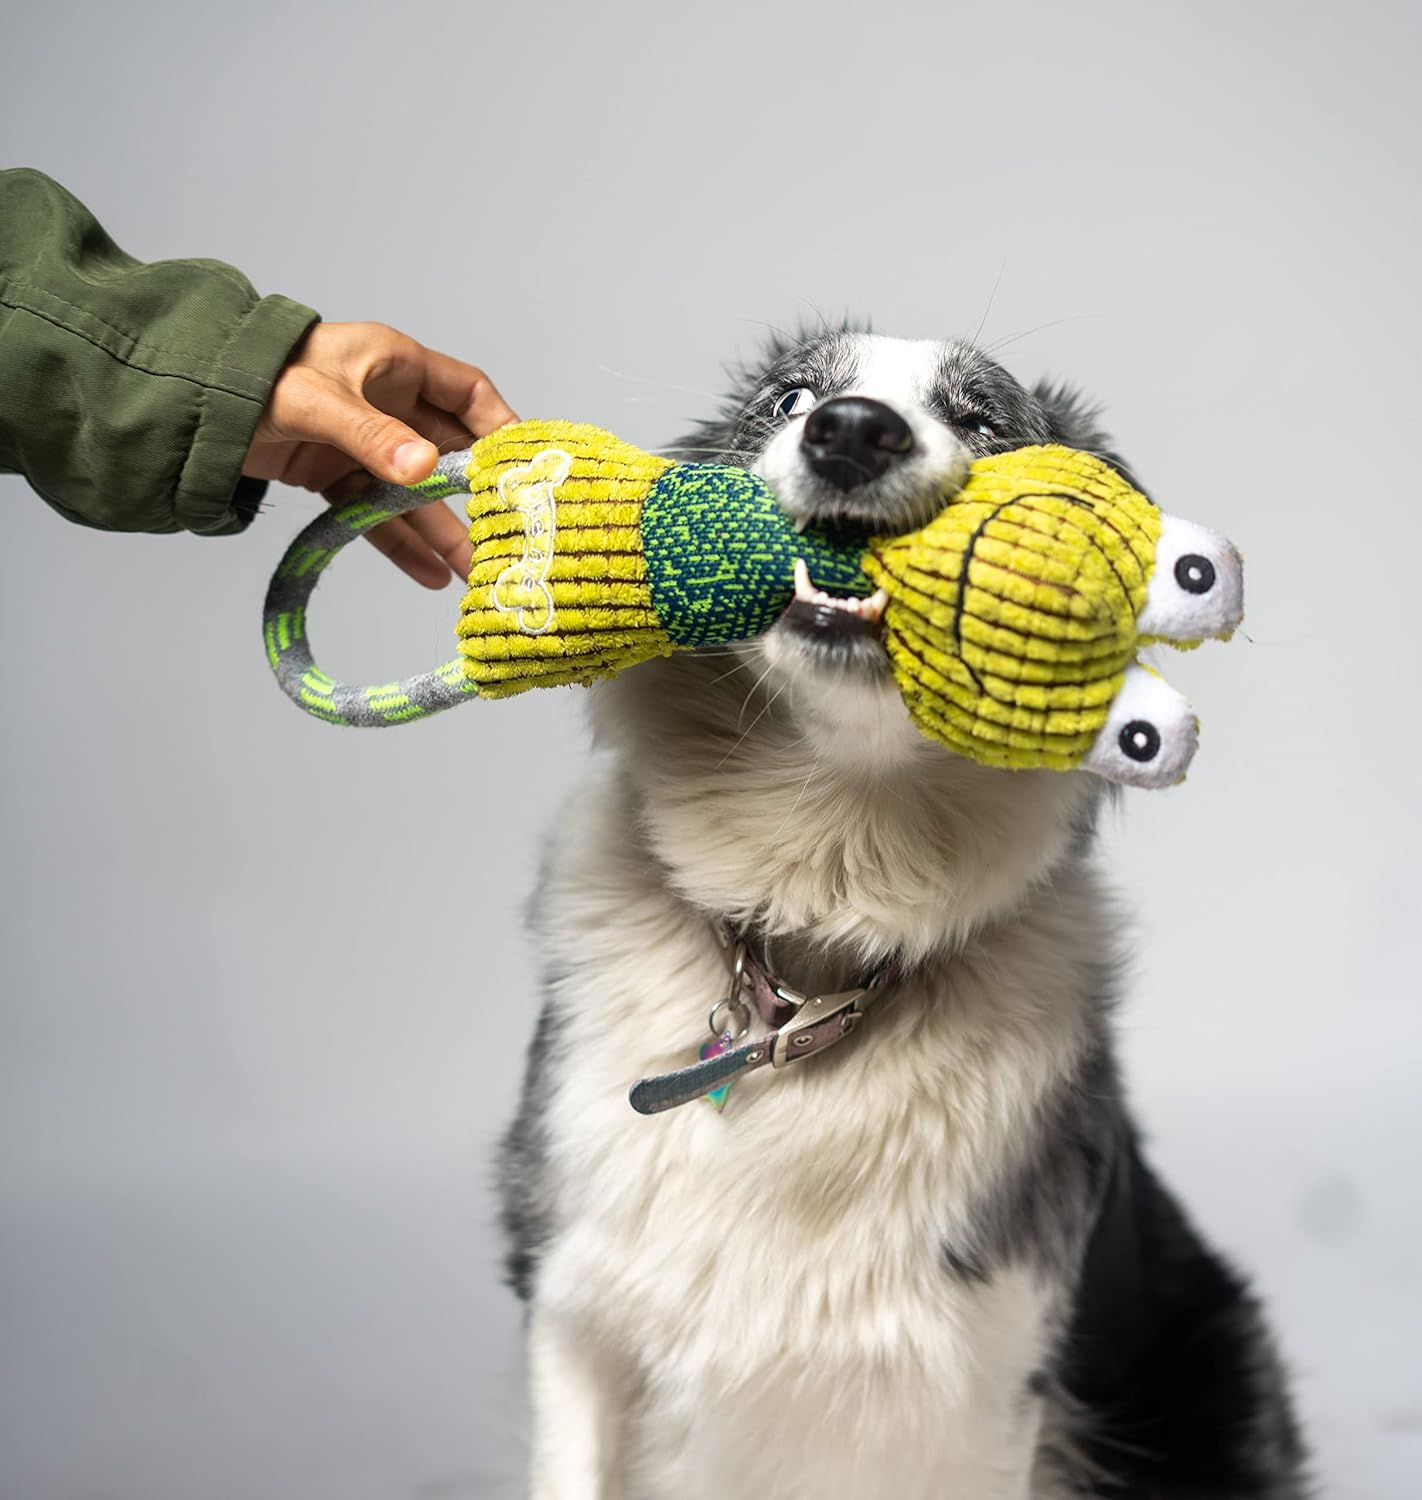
642, 464, 875, 647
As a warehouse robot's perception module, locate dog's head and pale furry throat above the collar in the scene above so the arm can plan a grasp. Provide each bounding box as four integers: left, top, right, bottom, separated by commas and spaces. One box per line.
597, 330, 1124, 953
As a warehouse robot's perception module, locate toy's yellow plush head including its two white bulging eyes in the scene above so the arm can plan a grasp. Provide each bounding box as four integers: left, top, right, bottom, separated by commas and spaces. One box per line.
866, 447, 1244, 786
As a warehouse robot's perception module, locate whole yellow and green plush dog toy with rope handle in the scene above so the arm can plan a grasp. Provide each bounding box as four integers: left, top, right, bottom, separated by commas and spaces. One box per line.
264, 422, 1244, 786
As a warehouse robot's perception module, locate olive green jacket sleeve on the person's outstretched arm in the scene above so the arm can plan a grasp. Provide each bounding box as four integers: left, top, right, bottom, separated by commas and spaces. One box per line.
0, 168, 317, 536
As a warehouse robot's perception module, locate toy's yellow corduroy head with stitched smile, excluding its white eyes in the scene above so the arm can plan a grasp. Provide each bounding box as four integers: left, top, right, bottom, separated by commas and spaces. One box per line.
864, 447, 1161, 770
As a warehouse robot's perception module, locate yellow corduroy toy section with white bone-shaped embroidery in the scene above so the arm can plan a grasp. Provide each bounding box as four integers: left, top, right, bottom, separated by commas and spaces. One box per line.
458, 422, 672, 698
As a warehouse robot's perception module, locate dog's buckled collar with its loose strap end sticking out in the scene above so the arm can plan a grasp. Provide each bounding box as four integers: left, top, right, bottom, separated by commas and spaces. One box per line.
629, 924, 902, 1115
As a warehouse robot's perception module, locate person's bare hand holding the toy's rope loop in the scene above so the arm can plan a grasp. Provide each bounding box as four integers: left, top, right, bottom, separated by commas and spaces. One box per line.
242, 323, 518, 588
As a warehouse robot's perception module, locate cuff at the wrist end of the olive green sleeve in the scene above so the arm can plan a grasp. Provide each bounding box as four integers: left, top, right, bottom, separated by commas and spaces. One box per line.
174, 297, 318, 537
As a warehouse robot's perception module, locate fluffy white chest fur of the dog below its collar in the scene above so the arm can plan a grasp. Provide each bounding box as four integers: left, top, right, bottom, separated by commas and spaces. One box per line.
533, 768, 1086, 1500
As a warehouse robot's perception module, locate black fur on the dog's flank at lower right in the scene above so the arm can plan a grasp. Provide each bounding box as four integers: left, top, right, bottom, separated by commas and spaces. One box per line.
941, 864, 1310, 1500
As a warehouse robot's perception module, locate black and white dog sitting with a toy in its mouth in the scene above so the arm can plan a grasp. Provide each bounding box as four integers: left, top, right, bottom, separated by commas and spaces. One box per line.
504, 330, 1307, 1500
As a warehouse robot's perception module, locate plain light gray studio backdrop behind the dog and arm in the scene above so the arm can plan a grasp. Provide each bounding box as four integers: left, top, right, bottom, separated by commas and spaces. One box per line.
0, 0, 1422, 1500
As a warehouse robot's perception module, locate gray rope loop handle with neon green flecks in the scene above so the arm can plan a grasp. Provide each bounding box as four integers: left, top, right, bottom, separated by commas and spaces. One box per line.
263, 449, 477, 729
